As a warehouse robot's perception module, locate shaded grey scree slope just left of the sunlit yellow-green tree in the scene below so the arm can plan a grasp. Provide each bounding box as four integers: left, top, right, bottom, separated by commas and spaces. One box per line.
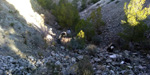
80, 0, 150, 44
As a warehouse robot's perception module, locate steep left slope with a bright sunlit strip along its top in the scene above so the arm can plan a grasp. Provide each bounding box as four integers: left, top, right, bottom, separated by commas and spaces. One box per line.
0, 0, 55, 58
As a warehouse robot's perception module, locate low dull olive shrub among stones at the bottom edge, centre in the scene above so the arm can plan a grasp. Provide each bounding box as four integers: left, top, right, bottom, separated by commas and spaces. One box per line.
66, 56, 94, 75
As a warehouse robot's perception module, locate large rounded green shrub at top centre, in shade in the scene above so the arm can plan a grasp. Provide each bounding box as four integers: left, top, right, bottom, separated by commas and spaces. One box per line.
52, 0, 80, 29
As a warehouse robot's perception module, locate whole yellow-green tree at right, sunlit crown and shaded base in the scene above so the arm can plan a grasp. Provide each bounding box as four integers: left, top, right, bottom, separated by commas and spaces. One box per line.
119, 0, 150, 42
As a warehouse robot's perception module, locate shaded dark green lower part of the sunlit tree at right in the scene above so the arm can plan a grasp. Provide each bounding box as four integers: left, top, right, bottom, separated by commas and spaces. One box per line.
119, 22, 149, 42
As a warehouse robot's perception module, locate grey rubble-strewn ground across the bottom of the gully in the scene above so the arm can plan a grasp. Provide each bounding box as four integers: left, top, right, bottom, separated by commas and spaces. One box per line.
0, 46, 150, 75
